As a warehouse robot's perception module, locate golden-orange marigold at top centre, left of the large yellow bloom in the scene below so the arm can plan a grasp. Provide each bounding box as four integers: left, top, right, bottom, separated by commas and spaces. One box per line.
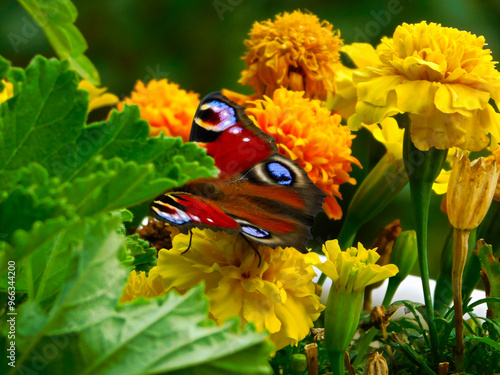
239, 10, 342, 100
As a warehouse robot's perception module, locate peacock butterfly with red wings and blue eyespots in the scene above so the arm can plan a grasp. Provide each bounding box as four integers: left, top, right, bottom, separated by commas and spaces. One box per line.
150, 93, 326, 253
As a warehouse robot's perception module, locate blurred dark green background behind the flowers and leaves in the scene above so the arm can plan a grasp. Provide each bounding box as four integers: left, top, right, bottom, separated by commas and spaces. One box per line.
0, 0, 500, 276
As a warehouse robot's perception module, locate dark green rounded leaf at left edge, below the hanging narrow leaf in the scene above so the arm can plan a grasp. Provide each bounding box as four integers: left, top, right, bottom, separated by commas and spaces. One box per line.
0, 57, 88, 170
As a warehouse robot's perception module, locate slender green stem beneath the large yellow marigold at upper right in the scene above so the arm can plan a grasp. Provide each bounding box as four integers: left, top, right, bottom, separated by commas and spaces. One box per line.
410, 180, 439, 363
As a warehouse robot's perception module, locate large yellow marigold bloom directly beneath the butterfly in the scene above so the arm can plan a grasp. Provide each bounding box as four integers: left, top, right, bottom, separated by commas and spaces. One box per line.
156, 229, 324, 349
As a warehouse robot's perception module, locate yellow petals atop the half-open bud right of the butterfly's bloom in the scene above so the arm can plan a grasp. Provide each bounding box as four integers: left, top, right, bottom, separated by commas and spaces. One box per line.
313, 240, 399, 294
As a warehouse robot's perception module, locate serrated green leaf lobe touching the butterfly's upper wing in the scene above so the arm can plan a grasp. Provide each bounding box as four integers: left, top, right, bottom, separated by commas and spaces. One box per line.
45, 106, 217, 184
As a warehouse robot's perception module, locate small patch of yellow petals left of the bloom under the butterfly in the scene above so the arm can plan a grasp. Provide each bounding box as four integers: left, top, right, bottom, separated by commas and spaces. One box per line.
120, 267, 165, 302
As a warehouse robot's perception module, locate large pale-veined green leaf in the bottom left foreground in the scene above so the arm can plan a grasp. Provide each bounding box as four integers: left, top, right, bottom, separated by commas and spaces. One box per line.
8, 215, 271, 374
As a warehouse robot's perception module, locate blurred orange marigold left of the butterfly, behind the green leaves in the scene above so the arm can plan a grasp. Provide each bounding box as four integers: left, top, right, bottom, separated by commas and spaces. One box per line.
118, 79, 200, 142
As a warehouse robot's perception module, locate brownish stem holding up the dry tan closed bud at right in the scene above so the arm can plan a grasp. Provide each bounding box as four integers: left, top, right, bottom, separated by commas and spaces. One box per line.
451, 228, 470, 372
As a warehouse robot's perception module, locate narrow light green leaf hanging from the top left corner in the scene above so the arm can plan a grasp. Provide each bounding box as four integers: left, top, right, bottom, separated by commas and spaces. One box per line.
18, 0, 100, 86
